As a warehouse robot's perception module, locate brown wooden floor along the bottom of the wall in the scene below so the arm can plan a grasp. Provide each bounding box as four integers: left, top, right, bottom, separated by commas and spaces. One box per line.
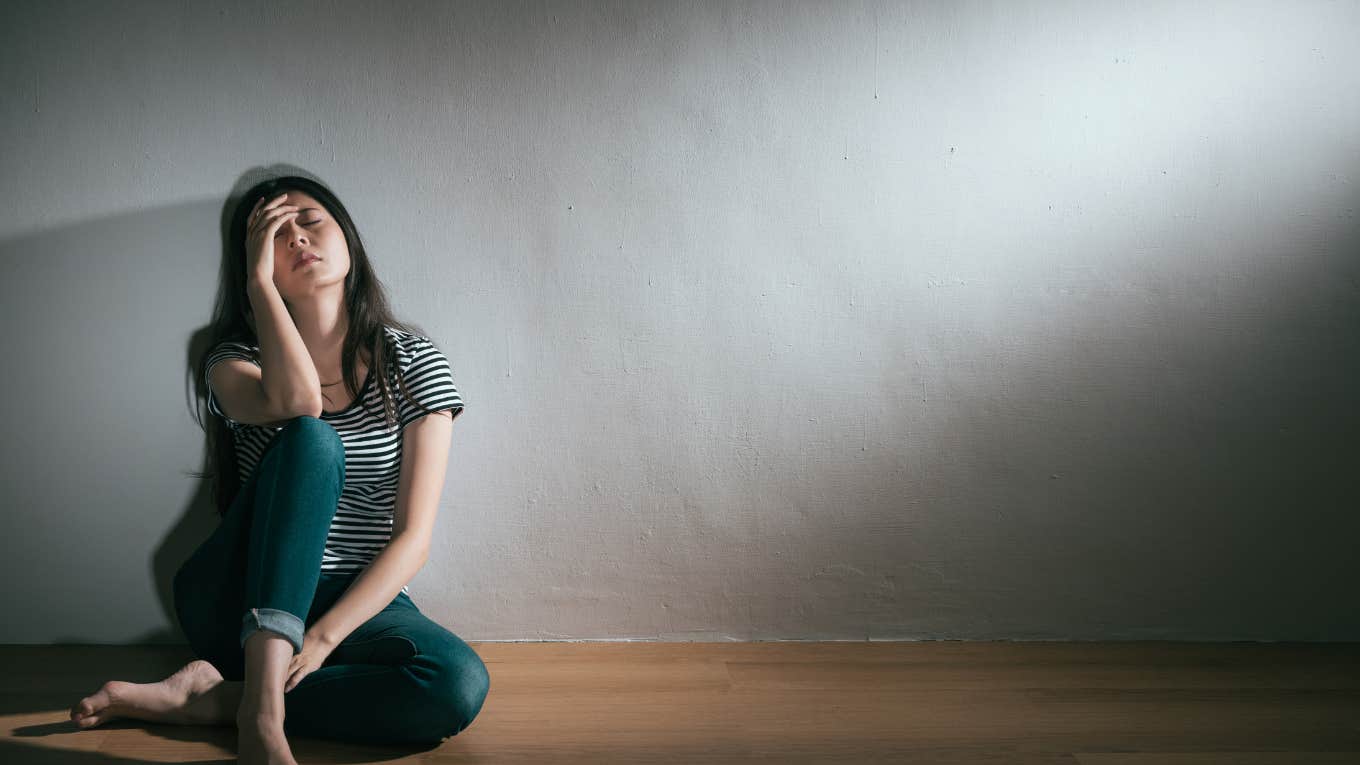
0, 642, 1360, 765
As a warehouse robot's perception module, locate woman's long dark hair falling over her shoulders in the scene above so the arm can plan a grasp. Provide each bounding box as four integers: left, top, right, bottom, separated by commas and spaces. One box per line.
193, 176, 432, 515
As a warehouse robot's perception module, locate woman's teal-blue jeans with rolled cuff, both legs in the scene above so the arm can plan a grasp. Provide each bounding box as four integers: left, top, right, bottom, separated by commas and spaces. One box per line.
174, 417, 491, 743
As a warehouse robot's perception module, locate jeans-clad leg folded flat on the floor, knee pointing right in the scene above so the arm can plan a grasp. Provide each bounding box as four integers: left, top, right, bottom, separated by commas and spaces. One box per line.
283, 593, 491, 743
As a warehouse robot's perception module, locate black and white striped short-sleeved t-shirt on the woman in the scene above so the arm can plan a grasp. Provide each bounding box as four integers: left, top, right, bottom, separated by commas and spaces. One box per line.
204, 327, 462, 595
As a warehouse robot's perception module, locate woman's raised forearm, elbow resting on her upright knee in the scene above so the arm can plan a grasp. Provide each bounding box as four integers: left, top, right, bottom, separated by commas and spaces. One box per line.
246, 276, 321, 415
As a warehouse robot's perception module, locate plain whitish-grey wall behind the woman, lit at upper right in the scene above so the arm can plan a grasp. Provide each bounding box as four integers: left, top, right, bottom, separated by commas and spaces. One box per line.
0, 1, 1360, 642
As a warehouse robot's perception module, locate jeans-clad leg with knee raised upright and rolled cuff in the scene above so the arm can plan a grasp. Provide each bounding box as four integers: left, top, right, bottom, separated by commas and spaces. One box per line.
174, 417, 344, 681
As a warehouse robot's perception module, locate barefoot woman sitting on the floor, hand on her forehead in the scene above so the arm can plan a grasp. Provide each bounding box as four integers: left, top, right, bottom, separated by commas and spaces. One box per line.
71, 177, 490, 762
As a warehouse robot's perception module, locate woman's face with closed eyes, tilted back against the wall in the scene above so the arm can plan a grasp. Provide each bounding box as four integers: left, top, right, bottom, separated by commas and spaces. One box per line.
273, 191, 350, 299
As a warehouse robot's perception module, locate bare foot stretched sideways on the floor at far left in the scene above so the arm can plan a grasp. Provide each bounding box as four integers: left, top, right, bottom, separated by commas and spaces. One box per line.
71, 659, 231, 728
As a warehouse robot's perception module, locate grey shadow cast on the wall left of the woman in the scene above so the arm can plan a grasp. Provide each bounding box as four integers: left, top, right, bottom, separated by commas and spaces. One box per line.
0, 166, 345, 645
